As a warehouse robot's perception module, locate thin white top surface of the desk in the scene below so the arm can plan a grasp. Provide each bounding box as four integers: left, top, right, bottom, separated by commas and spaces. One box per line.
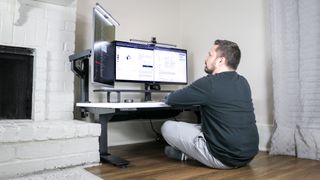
76, 102, 170, 109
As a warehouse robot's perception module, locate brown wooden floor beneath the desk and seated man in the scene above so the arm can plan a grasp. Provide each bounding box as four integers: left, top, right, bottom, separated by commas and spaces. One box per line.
87, 142, 320, 180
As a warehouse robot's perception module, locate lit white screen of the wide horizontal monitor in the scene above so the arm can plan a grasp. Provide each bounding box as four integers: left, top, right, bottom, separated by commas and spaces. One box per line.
115, 42, 187, 84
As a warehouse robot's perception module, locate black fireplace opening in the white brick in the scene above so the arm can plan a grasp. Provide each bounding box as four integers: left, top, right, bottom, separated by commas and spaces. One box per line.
0, 45, 34, 120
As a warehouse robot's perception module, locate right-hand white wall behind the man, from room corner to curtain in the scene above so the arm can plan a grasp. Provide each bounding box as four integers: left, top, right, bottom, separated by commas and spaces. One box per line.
181, 0, 273, 150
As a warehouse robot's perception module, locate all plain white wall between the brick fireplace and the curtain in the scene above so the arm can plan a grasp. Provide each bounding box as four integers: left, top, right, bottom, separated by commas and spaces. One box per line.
76, 0, 272, 149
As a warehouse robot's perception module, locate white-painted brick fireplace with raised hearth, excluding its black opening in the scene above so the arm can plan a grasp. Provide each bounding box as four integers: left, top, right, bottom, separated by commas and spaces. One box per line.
0, 0, 100, 179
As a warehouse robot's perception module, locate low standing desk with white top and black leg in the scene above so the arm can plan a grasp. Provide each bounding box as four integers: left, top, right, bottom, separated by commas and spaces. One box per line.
76, 102, 195, 167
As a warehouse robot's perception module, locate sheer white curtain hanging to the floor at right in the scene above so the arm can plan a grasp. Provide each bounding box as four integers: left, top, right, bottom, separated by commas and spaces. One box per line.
269, 0, 320, 160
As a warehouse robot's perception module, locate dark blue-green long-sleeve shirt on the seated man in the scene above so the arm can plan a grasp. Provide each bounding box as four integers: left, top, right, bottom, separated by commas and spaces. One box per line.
166, 71, 259, 167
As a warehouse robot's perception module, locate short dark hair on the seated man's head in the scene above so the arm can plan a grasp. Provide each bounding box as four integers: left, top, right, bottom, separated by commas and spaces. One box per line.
214, 39, 241, 70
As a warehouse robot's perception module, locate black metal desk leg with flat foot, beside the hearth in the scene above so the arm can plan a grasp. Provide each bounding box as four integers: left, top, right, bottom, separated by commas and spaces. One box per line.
99, 114, 129, 168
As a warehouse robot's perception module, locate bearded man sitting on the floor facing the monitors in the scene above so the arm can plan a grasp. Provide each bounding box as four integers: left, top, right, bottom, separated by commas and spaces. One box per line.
161, 40, 259, 169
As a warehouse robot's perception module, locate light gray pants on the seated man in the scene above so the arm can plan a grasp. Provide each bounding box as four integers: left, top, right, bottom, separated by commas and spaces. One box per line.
161, 121, 231, 169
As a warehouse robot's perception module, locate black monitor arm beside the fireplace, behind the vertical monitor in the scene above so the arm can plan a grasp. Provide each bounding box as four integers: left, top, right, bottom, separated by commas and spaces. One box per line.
69, 49, 91, 117
